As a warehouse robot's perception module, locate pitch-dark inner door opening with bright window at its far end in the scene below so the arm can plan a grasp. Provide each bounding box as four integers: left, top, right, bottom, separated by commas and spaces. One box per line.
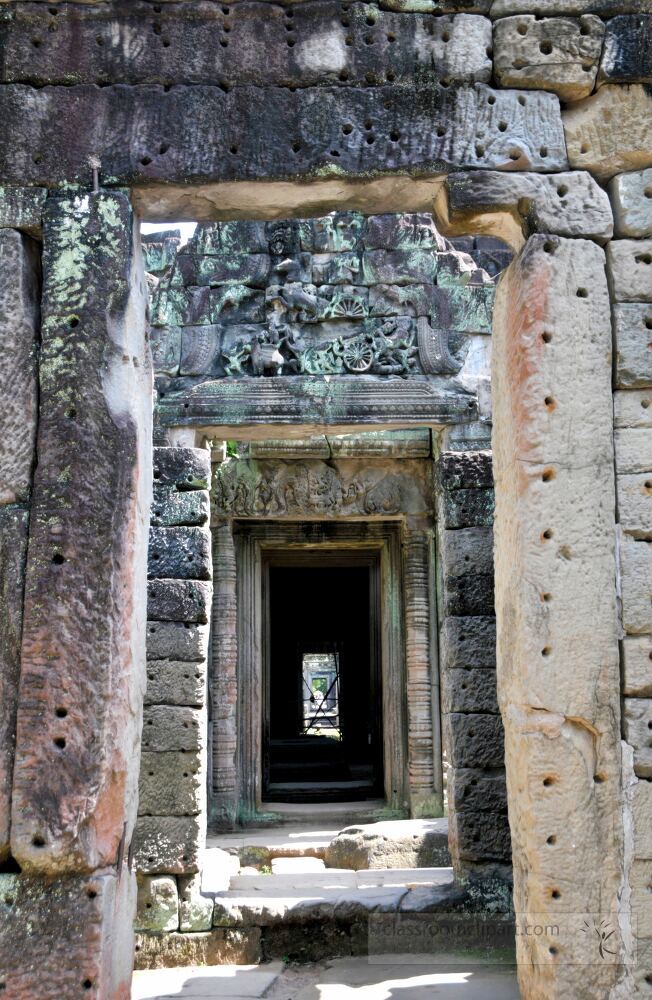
262, 551, 383, 802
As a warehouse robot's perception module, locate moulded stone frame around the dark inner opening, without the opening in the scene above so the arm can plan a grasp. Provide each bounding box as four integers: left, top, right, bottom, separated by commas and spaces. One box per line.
225, 520, 410, 818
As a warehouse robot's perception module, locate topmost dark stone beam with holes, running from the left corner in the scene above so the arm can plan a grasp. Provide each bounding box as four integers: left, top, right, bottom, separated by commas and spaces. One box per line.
0, 0, 491, 87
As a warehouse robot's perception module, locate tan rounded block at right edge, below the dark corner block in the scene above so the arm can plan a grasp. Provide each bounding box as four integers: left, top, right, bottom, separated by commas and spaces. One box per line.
562, 84, 652, 181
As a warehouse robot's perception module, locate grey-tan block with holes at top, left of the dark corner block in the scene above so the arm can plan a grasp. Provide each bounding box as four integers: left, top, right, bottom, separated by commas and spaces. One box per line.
494, 14, 605, 101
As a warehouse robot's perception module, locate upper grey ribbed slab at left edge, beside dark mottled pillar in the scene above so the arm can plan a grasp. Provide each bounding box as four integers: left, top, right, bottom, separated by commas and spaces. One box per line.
0, 229, 40, 503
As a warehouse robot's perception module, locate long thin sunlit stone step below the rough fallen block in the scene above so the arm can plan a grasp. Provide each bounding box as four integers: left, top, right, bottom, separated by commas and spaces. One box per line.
229, 868, 453, 896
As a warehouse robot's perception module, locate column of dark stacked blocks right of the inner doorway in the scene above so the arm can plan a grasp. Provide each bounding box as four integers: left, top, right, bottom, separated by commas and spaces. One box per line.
437, 451, 511, 878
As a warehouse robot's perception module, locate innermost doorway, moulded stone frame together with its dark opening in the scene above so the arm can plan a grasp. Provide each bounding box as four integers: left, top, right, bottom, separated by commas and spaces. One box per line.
232, 519, 409, 816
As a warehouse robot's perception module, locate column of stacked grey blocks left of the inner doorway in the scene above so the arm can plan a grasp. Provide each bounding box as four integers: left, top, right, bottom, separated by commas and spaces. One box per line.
135, 448, 212, 932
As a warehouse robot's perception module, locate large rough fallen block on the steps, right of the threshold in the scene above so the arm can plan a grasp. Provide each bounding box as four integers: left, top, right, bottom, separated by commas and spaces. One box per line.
326, 819, 450, 871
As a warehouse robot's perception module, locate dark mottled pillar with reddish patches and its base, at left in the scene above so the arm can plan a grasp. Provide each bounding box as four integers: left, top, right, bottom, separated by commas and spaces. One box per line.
0, 192, 152, 1000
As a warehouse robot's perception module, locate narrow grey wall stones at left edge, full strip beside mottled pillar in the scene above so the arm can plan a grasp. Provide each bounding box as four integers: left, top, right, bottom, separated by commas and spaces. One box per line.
0, 229, 40, 860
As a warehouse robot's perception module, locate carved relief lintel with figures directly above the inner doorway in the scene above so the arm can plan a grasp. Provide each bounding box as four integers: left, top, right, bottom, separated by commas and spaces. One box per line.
213, 460, 432, 517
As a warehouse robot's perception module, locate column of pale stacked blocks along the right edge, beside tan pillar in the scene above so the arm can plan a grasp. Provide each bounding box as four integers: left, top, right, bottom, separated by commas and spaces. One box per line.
607, 188, 652, 985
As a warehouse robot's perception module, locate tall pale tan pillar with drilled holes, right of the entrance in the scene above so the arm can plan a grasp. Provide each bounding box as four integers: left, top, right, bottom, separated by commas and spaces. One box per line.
492, 236, 623, 1000
